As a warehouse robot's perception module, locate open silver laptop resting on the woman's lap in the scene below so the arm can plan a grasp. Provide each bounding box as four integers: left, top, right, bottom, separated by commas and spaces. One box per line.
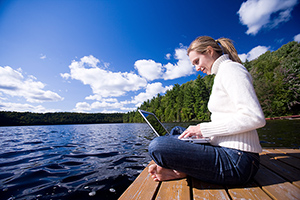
138, 109, 210, 143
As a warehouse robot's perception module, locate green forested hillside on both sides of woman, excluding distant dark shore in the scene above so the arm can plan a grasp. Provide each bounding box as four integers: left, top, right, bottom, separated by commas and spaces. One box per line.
123, 42, 300, 122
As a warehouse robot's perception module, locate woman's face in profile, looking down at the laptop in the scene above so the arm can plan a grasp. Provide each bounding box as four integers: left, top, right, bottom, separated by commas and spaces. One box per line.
189, 50, 215, 75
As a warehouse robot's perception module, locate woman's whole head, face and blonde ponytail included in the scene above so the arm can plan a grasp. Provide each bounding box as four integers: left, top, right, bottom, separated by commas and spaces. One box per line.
187, 36, 242, 74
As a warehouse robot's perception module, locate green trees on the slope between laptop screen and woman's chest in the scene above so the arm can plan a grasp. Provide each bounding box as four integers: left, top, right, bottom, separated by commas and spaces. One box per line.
124, 75, 214, 122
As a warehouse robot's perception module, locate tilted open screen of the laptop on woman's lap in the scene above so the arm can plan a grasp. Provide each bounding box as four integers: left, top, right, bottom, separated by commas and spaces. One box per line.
139, 110, 168, 136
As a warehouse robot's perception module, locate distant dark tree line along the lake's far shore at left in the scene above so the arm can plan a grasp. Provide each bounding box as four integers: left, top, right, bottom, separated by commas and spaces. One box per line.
0, 111, 124, 126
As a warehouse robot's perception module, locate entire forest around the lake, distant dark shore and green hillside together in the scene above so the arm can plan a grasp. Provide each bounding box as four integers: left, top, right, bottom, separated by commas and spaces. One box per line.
0, 42, 300, 126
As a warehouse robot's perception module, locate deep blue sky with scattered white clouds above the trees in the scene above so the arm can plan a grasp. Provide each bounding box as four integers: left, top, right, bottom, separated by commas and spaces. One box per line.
0, 0, 300, 113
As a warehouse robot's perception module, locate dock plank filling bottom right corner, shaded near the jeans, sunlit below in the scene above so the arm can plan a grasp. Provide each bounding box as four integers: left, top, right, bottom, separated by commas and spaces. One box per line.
254, 167, 300, 200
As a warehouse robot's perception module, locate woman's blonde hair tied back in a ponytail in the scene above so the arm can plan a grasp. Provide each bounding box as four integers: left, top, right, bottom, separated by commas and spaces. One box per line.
187, 36, 242, 63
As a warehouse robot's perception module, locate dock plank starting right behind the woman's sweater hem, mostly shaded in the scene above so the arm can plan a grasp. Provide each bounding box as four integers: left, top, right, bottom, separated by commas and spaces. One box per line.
263, 149, 300, 169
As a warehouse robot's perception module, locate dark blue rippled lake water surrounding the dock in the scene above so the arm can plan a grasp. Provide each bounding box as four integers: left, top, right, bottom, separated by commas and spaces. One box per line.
0, 120, 300, 200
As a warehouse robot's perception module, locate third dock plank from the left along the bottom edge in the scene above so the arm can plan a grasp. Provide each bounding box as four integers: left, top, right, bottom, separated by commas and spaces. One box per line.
192, 179, 230, 200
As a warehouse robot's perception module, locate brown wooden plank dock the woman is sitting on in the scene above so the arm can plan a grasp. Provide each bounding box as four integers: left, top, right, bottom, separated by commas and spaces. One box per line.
119, 148, 300, 200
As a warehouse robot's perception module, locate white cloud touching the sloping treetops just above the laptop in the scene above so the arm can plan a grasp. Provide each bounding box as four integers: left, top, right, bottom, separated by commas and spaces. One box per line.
130, 82, 173, 107
